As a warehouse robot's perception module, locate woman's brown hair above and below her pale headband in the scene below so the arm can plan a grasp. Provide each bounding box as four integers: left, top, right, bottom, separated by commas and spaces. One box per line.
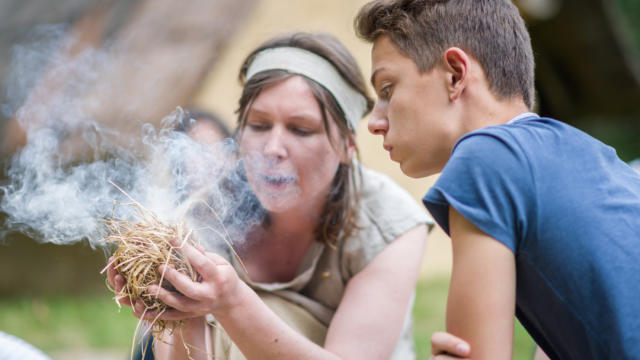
237, 33, 373, 245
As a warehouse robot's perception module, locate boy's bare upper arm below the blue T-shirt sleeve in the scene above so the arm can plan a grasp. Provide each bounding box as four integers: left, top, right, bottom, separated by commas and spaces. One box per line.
447, 207, 516, 360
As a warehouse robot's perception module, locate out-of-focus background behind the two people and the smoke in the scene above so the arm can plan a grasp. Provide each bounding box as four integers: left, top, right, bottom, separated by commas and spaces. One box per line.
0, 0, 640, 359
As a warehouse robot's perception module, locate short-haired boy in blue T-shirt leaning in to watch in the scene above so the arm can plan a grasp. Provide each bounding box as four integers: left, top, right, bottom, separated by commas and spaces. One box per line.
356, 0, 640, 359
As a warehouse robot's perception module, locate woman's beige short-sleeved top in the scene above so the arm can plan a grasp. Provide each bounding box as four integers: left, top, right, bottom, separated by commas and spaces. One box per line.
212, 168, 433, 359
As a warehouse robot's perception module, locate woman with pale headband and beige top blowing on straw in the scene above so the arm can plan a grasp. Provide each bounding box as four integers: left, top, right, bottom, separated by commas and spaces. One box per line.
109, 33, 431, 359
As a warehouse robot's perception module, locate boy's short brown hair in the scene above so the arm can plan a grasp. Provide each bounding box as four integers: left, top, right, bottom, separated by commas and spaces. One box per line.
354, 0, 534, 109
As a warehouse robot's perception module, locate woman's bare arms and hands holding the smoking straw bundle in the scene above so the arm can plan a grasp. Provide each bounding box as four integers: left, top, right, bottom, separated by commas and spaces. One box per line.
114, 225, 427, 359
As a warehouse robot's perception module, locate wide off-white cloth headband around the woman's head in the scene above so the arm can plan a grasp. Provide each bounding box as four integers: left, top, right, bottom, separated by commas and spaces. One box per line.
246, 47, 367, 132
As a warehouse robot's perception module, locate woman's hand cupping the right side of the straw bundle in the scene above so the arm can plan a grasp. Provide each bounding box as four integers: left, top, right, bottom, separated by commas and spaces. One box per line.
133, 243, 241, 320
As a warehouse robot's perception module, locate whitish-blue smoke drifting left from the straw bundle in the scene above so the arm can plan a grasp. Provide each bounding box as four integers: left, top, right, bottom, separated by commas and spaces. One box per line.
0, 26, 264, 249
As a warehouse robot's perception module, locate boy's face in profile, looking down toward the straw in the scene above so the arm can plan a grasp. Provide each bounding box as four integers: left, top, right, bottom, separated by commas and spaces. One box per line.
369, 35, 460, 178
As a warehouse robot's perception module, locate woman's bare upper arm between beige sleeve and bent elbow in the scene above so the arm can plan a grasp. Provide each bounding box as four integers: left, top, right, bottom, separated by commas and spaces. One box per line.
325, 225, 427, 359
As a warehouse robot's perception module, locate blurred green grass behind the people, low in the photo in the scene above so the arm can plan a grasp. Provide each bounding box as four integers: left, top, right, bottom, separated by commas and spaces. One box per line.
0, 277, 534, 360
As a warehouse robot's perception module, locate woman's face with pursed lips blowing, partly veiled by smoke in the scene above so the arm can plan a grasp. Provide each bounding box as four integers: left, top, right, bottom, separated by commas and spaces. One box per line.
240, 76, 347, 213
